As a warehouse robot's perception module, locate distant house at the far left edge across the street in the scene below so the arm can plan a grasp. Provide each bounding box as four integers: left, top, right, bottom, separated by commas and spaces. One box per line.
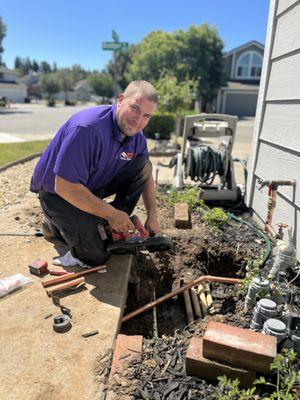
0, 67, 27, 103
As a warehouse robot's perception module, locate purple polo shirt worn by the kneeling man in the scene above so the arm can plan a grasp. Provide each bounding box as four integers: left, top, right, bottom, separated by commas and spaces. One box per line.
30, 104, 149, 193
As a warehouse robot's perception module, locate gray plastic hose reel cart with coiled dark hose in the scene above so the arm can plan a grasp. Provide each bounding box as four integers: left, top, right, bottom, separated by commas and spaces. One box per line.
173, 114, 240, 202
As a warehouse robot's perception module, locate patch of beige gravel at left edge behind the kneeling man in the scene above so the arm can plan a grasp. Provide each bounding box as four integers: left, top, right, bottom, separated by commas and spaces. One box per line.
0, 158, 38, 210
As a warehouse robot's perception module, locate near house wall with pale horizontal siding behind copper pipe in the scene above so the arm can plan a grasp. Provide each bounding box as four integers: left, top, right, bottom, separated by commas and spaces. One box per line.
247, 0, 300, 259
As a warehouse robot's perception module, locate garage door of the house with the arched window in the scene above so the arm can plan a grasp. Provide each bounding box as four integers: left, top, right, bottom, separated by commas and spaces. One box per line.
225, 93, 258, 117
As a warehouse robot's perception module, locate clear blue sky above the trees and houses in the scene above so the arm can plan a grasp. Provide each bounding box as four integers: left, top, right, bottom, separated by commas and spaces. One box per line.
0, 0, 269, 70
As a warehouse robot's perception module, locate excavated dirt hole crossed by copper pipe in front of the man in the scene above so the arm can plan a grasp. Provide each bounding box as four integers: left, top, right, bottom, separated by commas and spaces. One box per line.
121, 237, 244, 338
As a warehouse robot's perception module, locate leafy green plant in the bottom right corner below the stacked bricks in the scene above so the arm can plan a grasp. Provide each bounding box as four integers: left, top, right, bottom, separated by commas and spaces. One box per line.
216, 349, 300, 400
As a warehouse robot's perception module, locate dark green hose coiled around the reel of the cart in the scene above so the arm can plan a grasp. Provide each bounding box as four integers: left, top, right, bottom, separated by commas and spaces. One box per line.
185, 145, 226, 185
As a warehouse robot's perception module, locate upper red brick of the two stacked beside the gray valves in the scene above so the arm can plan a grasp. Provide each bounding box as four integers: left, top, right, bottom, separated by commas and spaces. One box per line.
203, 321, 277, 373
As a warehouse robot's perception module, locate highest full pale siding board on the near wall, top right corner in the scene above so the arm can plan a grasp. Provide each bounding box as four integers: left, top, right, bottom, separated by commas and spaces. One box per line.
272, 3, 300, 58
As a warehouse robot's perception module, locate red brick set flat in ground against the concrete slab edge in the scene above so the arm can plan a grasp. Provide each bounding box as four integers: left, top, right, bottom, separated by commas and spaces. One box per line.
109, 334, 143, 382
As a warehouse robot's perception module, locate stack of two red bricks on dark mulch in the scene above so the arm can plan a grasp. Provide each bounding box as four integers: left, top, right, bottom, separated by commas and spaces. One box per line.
186, 322, 277, 387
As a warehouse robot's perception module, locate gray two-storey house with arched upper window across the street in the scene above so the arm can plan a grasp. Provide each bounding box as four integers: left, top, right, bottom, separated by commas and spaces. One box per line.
216, 40, 264, 117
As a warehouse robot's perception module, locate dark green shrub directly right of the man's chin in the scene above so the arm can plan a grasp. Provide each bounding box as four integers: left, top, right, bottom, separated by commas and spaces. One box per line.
143, 113, 175, 140
